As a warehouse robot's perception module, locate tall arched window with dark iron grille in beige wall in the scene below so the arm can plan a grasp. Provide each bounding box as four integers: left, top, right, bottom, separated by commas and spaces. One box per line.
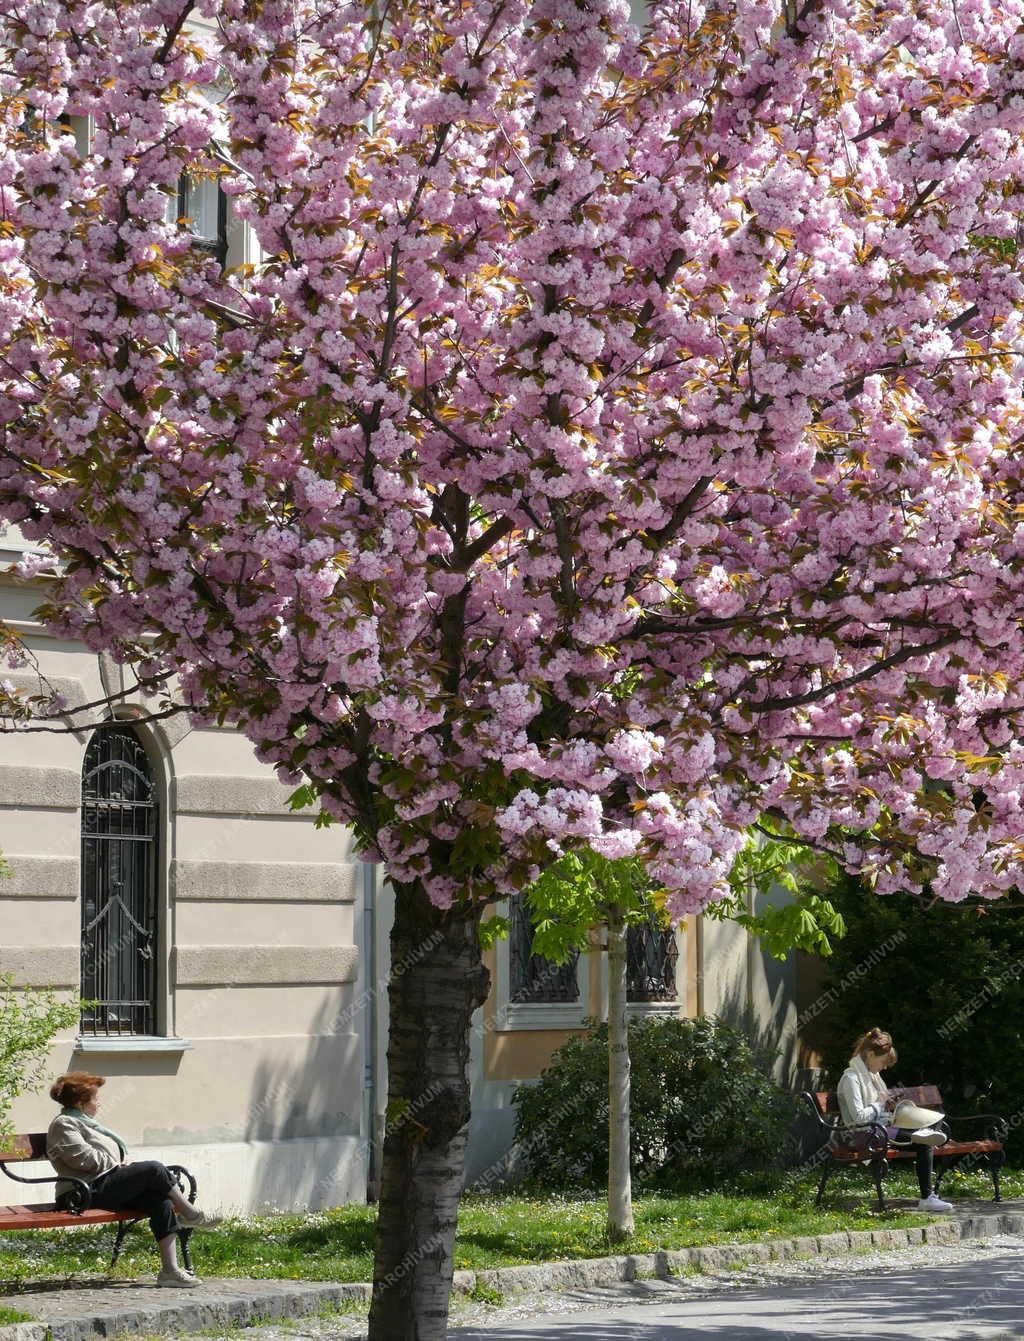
82, 724, 158, 1034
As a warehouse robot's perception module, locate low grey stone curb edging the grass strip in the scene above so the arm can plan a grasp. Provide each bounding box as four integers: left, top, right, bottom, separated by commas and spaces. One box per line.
0, 1212, 1024, 1341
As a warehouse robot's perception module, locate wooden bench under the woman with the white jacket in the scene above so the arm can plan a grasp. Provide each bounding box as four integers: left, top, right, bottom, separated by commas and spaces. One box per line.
800, 1085, 1009, 1211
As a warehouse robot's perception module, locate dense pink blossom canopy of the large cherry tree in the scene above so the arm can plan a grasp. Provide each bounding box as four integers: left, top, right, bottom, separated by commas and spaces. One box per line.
0, 0, 1024, 915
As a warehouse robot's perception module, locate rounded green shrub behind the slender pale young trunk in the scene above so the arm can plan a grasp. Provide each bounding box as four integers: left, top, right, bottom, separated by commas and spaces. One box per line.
515, 1018, 793, 1188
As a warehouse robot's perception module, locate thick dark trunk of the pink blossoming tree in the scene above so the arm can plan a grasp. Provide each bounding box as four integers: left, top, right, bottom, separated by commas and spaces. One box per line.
370, 885, 488, 1341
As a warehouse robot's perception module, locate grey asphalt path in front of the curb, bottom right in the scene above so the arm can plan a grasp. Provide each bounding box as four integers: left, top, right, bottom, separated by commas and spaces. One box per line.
450, 1250, 1024, 1341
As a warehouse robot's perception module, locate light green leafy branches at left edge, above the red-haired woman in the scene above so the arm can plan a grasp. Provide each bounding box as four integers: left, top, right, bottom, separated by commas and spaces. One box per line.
0, 856, 80, 1149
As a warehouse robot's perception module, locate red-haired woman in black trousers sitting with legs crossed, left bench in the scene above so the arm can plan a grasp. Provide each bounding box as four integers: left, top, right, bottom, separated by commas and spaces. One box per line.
46, 1071, 220, 1289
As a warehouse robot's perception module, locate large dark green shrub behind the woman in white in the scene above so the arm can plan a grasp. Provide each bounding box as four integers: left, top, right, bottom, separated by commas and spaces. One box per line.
803, 878, 1024, 1164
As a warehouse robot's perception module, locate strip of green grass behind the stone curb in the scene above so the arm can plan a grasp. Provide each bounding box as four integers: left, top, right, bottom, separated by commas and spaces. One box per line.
0, 1169, 1007, 1287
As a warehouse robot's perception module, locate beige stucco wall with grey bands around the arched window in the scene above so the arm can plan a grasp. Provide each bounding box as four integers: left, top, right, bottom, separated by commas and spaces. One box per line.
0, 552, 366, 1210
